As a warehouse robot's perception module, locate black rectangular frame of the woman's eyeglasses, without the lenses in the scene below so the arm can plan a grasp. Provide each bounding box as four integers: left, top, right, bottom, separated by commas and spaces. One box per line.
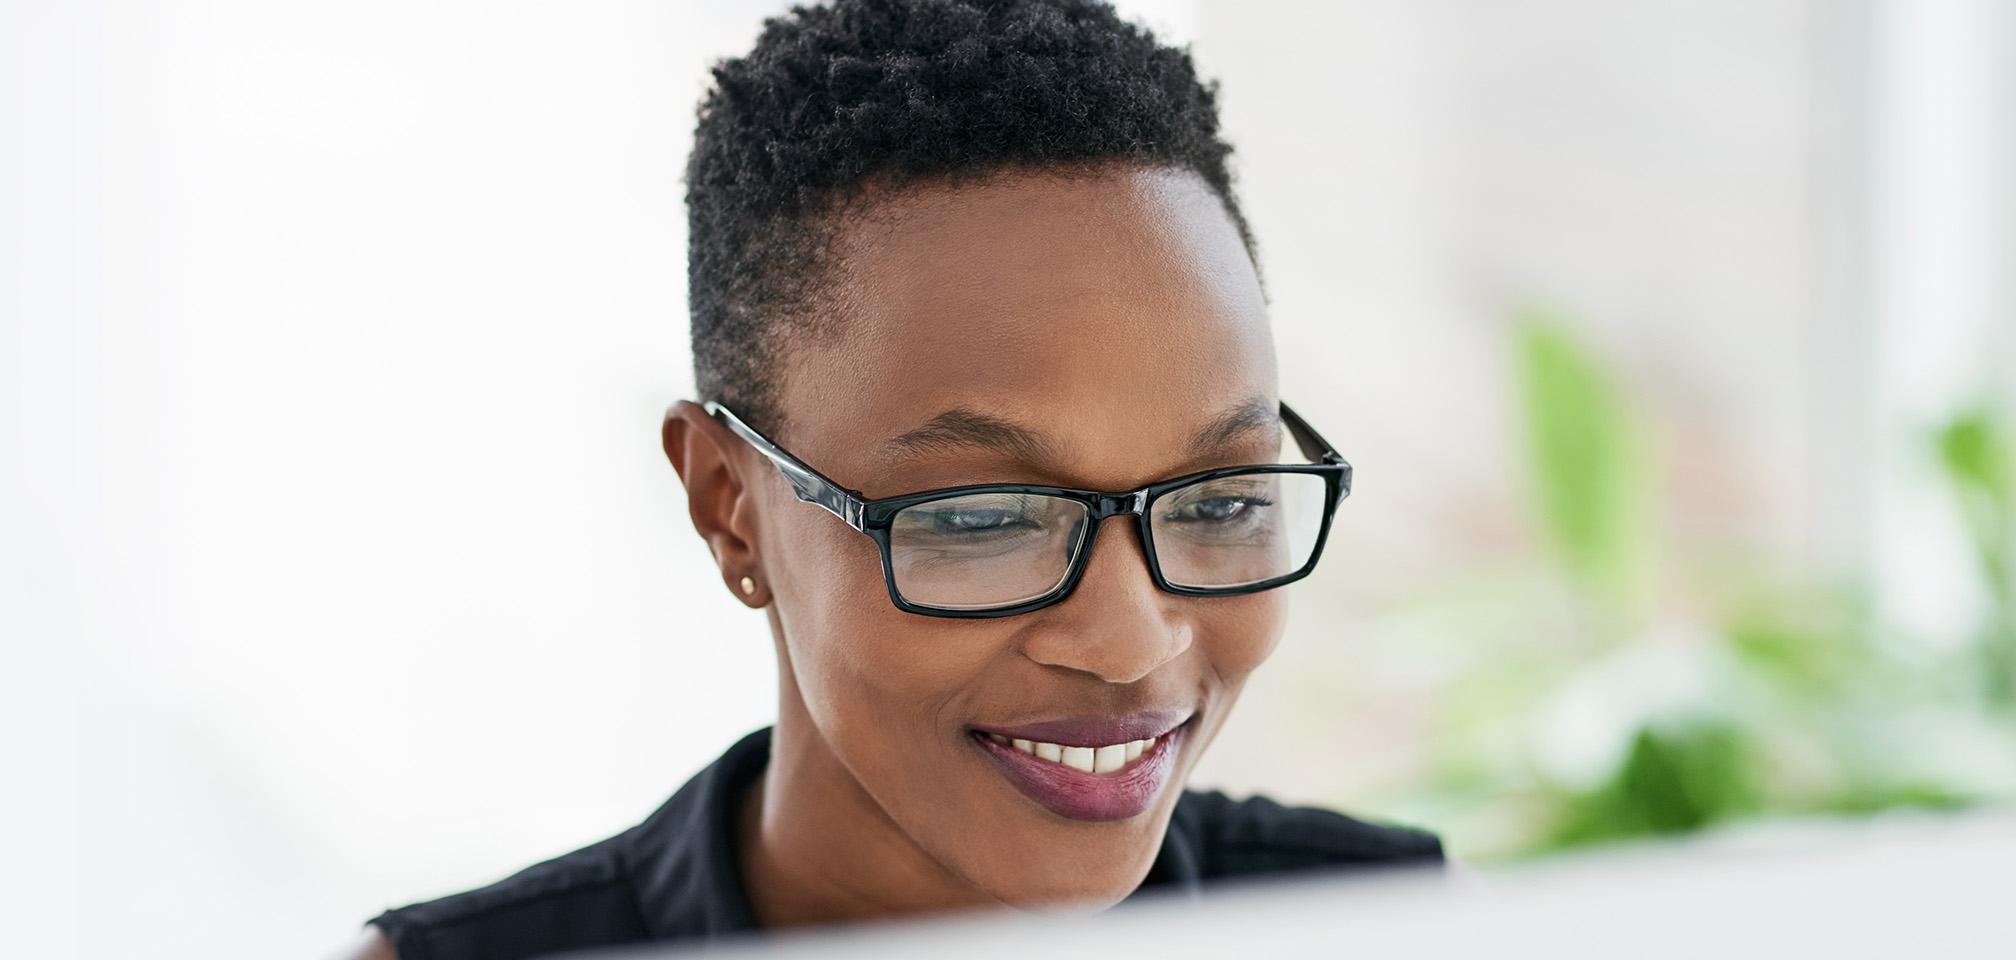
702, 399, 1351, 619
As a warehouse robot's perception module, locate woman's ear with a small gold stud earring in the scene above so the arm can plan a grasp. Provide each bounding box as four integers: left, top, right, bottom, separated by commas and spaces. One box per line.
661, 399, 770, 607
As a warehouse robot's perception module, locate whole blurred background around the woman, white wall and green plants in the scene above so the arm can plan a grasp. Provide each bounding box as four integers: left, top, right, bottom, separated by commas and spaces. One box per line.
0, 0, 2016, 958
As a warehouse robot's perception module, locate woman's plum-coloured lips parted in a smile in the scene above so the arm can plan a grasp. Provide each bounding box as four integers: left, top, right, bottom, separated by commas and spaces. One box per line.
968, 710, 1195, 821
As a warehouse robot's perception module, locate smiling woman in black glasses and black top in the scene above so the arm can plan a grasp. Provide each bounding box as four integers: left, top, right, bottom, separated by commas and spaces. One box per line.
355, 0, 1441, 960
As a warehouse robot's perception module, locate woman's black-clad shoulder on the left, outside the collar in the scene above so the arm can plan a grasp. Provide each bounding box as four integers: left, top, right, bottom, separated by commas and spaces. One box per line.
355, 835, 645, 960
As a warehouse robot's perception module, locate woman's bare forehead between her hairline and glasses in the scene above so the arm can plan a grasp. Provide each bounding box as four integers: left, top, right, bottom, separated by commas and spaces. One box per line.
780, 167, 1274, 496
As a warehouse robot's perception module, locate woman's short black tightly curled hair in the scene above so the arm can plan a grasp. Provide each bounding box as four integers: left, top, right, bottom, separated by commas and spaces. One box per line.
685, 0, 1264, 436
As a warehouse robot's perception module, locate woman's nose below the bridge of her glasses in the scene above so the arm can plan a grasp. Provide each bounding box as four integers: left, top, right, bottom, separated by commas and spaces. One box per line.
1022, 516, 1193, 684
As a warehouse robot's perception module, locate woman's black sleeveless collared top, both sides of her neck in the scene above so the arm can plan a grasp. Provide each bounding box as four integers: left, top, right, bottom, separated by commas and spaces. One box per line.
371, 726, 1441, 960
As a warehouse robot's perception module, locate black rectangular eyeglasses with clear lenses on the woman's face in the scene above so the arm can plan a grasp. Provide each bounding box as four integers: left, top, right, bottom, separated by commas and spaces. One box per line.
706, 401, 1351, 617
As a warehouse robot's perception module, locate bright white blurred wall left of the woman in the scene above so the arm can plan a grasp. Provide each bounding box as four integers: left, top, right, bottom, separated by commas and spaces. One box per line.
0, 2, 794, 956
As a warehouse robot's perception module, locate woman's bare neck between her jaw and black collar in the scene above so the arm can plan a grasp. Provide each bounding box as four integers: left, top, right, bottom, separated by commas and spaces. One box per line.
736, 657, 994, 928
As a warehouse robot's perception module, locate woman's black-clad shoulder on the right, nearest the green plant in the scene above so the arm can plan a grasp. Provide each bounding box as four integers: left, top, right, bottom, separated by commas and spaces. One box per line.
1169, 791, 1443, 877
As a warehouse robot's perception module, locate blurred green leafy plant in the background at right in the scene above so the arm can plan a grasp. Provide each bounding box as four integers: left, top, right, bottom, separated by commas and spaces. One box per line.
1415, 315, 2016, 861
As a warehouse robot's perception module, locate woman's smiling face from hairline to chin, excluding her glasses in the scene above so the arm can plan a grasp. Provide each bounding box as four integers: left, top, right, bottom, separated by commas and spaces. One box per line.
744, 167, 1286, 906
